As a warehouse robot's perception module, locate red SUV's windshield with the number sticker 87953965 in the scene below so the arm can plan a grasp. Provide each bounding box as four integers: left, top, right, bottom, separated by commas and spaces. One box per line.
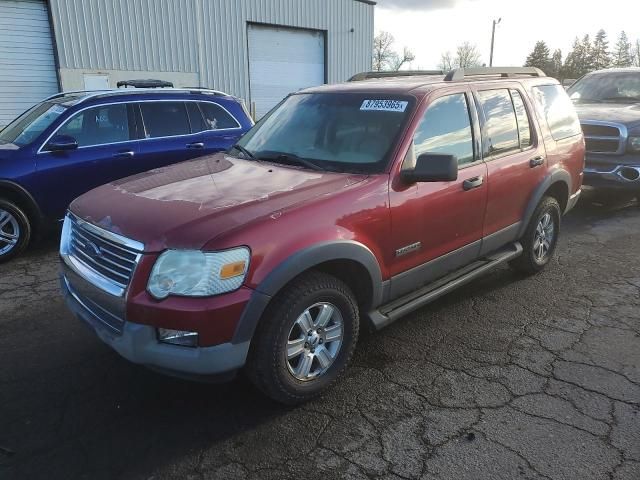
236, 93, 413, 173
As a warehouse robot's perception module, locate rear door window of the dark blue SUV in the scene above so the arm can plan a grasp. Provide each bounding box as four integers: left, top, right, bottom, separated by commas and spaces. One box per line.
140, 102, 191, 138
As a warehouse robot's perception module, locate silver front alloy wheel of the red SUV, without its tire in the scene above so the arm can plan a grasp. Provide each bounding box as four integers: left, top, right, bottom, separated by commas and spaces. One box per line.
286, 302, 344, 381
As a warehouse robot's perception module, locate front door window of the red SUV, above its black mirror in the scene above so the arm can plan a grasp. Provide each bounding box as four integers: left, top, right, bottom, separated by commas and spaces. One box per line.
413, 93, 473, 165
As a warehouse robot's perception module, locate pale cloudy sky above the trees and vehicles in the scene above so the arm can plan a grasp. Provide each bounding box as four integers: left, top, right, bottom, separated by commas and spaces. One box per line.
375, 0, 640, 69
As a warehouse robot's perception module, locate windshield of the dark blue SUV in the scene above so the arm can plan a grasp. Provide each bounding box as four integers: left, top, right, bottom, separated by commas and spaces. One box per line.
0, 102, 67, 147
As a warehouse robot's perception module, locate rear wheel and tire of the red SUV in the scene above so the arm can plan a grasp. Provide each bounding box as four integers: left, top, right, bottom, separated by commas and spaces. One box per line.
509, 197, 561, 275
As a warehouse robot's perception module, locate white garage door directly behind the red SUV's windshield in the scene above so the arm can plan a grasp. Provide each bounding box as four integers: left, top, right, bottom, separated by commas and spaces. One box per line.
249, 25, 325, 118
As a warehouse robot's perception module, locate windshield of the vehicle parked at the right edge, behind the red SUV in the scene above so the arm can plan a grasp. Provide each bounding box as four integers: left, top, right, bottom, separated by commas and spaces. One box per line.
569, 70, 640, 103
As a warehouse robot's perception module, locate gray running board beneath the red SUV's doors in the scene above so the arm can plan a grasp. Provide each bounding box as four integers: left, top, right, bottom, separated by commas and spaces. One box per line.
369, 242, 522, 330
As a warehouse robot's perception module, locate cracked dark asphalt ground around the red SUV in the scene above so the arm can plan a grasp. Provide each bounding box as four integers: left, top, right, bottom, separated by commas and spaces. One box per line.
0, 196, 640, 480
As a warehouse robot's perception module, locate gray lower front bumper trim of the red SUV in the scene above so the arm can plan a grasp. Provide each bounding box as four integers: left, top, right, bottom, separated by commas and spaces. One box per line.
60, 276, 249, 375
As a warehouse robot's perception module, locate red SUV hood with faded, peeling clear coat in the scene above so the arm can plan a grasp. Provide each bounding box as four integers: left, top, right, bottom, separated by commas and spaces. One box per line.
70, 154, 366, 252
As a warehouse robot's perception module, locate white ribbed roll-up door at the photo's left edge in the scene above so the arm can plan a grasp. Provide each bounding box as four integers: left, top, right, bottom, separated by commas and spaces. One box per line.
0, 0, 58, 127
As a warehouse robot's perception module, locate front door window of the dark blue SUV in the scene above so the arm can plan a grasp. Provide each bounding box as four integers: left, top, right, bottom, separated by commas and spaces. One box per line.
57, 103, 131, 147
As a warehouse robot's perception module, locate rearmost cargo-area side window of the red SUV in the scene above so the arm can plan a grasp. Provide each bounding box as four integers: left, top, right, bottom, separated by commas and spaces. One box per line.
533, 85, 581, 140
